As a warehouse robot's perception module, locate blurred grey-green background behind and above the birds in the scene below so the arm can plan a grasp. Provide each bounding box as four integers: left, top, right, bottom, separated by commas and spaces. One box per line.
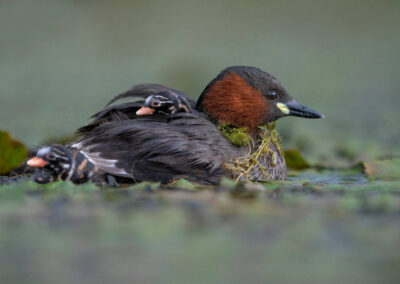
0, 0, 400, 166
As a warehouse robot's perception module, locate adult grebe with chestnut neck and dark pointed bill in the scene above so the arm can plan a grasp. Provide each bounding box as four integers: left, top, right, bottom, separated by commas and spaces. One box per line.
71, 66, 323, 184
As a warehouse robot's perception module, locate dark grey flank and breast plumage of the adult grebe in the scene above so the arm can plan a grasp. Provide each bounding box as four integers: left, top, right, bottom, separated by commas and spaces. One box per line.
73, 111, 286, 184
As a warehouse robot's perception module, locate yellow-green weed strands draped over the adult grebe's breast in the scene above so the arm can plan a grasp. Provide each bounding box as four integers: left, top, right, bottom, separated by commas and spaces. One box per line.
222, 122, 283, 181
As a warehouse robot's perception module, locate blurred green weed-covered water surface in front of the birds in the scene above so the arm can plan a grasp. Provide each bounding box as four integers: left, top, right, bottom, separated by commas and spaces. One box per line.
0, 166, 400, 283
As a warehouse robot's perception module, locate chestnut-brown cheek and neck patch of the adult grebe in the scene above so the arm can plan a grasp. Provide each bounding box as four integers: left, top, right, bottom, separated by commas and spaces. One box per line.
201, 73, 268, 131
